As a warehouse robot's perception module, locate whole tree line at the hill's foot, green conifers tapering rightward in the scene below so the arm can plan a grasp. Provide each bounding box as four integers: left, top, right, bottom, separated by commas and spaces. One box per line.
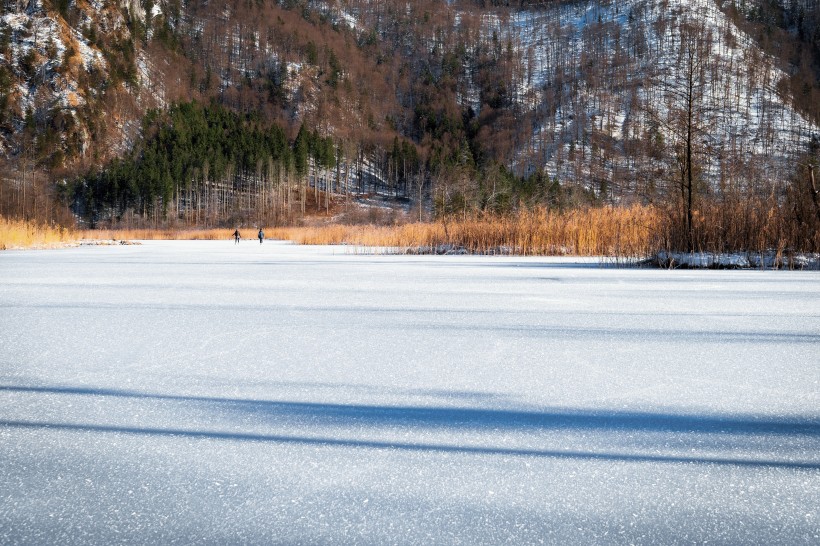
64, 101, 595, 227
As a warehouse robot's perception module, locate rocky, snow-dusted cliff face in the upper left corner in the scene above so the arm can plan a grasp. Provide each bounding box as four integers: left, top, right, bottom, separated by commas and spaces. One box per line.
0, 0, 153, 163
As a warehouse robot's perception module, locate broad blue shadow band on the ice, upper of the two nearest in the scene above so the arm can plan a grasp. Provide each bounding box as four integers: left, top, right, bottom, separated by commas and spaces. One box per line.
0, 385, 820, 437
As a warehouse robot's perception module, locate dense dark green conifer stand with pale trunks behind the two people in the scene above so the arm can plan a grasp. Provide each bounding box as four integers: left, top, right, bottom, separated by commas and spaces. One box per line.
62, 102, 335, 226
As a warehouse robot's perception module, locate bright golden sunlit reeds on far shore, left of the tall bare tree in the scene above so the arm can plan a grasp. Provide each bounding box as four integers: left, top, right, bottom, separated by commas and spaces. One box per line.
0, 206, 659, 257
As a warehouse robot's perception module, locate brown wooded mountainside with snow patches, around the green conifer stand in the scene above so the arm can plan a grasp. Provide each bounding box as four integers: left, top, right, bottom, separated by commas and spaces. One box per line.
0, 0, 820, 237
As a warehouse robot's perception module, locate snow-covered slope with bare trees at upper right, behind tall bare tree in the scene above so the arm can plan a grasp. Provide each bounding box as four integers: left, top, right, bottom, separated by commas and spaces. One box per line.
464, 0, 820, 197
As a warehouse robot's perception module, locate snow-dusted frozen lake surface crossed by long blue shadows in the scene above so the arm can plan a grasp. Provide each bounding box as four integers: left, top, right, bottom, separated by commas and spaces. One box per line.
0, 241, 820, 545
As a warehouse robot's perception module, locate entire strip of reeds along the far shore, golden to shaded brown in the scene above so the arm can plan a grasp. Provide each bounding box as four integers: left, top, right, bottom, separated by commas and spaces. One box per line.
0, 200, 820, 260
